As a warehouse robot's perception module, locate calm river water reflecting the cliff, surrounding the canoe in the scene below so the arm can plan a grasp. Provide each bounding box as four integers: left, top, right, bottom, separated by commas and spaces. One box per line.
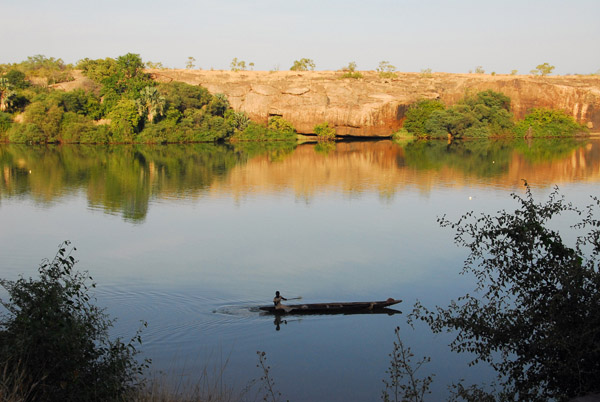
0, 140, 600, 401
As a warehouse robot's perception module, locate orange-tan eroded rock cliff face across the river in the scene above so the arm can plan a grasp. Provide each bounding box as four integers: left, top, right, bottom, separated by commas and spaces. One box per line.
149, 70, 600, 136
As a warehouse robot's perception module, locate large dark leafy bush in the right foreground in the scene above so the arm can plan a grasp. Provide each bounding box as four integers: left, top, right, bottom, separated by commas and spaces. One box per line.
418, 183, 600, 401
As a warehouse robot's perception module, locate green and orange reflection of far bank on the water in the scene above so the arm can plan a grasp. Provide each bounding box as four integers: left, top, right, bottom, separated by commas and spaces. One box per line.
0, 139, 600, 222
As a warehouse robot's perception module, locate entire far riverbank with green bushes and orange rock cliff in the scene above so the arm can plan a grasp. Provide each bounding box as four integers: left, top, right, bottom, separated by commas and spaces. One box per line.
0, 53, 600, 144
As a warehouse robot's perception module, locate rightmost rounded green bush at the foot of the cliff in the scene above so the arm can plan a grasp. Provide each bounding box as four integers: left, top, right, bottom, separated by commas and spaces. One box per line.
515, 108, 587, 137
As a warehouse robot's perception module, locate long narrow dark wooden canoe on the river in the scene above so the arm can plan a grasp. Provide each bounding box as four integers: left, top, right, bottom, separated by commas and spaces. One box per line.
259, 298, 402, 314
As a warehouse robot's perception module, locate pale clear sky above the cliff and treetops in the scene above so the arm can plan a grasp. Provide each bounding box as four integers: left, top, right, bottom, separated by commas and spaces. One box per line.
0, 0, 600, 74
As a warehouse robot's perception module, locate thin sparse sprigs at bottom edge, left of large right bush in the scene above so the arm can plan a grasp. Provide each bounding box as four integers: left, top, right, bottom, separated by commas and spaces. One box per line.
381, 327, 433, 402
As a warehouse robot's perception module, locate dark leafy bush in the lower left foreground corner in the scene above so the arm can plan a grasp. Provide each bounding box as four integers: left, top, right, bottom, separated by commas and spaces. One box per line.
0, 242, 147, 401
